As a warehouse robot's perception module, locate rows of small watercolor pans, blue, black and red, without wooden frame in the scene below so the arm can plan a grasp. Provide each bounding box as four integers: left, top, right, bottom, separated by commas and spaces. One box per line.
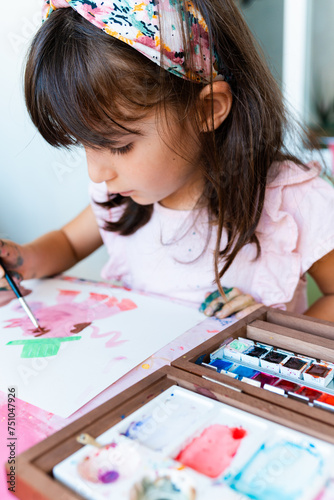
201, 337, 334, 412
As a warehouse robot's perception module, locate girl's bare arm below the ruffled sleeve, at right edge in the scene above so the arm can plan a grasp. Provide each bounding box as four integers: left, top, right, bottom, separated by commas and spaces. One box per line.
305, 250, 334, 321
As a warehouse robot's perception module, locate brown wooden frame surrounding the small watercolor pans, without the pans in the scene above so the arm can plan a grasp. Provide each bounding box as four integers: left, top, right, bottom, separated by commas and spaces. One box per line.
172, 307, 334, 425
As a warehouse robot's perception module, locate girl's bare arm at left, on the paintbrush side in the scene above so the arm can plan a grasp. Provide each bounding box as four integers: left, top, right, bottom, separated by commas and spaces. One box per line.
0, 206, 102, 287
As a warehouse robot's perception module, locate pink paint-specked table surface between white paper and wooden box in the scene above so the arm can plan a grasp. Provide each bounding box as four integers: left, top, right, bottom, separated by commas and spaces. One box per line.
0, 276, 235, 500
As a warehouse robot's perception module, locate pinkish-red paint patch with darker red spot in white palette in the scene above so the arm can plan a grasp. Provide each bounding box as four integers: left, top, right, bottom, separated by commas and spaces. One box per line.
175, 424, 247, 478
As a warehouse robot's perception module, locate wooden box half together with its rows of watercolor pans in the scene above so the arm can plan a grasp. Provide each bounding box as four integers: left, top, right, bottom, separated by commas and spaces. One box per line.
173, 308, 334, 423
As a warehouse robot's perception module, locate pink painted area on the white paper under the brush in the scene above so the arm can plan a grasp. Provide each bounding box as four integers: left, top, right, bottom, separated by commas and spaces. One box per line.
5, 290, 137, 347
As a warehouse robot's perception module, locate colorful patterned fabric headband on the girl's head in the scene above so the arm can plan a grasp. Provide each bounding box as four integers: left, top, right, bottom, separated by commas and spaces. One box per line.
43, 0, 225, 83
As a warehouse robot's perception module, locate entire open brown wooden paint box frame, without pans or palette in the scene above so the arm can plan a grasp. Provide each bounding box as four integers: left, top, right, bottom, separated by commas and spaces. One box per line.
9, 308, 334, 500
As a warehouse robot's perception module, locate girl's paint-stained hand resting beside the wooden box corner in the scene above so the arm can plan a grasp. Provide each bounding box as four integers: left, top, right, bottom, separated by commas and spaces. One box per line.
199, 288, 263, 319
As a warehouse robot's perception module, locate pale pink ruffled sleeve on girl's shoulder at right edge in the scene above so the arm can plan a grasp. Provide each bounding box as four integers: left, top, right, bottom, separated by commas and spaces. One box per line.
257, 162, 334, 274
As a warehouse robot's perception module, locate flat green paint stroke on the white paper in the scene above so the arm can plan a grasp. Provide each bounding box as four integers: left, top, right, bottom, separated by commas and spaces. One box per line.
6, 337, 81, 358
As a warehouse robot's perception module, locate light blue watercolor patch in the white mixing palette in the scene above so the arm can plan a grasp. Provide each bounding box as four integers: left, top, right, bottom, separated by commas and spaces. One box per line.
229, 441, 324, 500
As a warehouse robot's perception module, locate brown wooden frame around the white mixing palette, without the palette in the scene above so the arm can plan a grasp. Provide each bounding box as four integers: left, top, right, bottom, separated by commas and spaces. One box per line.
9, 364, 334, 500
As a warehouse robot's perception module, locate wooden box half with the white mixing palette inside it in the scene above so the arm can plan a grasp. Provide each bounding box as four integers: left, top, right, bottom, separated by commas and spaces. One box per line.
11, 366, 334, 500
